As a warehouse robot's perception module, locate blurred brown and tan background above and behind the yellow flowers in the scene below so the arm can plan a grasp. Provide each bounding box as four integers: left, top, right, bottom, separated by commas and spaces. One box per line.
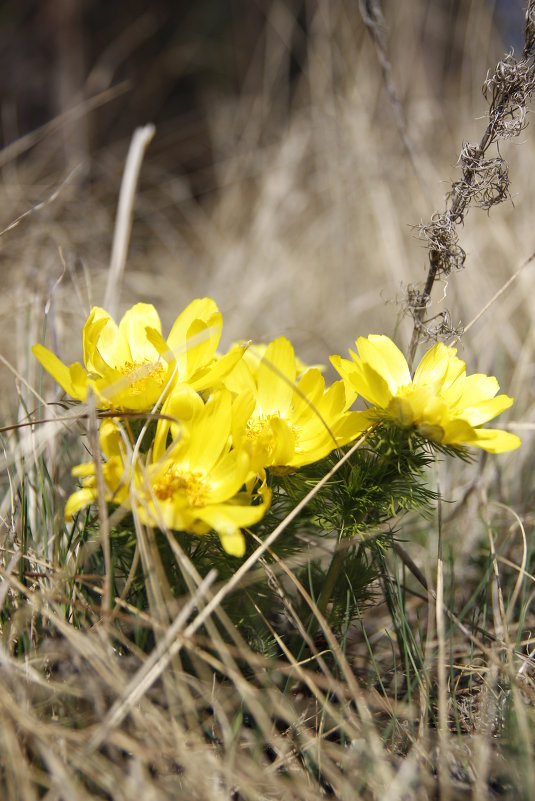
0, 0, 535, 422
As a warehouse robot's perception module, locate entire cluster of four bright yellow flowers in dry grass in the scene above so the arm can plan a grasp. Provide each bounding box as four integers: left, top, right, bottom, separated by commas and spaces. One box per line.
33, 298, 520, 556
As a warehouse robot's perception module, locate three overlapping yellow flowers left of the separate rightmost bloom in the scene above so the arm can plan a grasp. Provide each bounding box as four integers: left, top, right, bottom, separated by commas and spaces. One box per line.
33, 298, 368, 556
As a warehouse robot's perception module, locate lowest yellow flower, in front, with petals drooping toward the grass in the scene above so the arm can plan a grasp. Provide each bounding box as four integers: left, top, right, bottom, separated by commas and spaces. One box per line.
65, 388, 270, 556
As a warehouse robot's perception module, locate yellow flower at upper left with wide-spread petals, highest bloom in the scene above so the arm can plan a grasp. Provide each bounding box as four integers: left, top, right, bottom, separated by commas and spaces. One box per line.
32, 298, 243, 411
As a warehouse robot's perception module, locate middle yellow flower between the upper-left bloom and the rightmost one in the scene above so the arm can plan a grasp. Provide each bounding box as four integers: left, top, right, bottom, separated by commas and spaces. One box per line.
224, 337, 369, 474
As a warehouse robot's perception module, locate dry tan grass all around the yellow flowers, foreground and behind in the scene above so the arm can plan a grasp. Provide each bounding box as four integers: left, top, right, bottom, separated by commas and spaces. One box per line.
0, 0, 535, 801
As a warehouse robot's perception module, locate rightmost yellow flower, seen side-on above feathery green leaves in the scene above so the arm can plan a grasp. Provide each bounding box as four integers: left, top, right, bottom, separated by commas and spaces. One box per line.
331, 334, 521, 453
